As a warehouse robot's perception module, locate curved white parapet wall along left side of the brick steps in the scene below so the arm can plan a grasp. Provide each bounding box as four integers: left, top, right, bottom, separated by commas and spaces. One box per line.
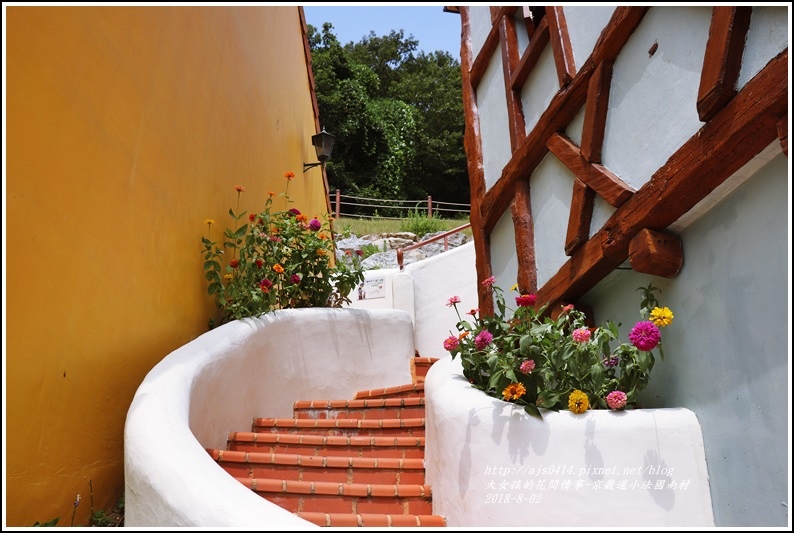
124, 309, 414, 530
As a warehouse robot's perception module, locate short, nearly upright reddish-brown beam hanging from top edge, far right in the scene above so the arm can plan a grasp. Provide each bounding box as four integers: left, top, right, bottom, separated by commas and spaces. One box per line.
697, 6, 753, 122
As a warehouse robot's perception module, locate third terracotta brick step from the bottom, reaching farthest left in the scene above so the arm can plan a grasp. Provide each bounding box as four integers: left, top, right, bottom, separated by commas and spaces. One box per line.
207, 449, 425, 485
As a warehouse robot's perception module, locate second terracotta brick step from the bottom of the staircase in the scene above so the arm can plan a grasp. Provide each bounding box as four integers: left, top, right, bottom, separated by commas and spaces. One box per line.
235, 477, 433, 515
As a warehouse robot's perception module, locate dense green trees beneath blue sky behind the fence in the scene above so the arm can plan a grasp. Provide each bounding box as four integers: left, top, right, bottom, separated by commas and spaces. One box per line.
308, 23, 469, 210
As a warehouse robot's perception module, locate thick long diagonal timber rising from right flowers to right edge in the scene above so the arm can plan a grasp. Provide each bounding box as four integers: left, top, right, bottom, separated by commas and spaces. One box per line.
538, 49, 789, 305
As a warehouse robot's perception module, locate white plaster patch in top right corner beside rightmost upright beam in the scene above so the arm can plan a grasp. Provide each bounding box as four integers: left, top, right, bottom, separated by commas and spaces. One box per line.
736, 5, 791, 89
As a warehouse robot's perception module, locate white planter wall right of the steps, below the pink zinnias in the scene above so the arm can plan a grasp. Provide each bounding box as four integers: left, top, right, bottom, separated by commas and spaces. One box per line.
425, 356, 714, 527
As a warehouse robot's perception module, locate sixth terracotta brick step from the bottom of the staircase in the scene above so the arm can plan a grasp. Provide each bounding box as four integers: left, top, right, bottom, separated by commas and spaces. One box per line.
293, 396, 425, 420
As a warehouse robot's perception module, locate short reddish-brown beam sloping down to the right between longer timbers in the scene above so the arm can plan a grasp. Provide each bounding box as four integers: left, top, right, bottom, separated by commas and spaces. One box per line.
546, 133, 634, 207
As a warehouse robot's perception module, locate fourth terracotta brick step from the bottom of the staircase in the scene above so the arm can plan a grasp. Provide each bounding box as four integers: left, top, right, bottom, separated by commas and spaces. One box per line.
226, 431, 425, 459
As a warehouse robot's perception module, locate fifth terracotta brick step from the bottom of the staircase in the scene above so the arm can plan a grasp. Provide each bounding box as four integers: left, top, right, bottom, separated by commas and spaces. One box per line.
251, 418, 425, 437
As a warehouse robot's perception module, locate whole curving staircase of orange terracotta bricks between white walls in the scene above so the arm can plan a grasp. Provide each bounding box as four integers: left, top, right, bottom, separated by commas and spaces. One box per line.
207, 354, 446, 527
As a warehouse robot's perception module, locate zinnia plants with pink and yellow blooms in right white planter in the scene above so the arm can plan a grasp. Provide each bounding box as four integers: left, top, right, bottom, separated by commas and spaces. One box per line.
444, 277, 673, 417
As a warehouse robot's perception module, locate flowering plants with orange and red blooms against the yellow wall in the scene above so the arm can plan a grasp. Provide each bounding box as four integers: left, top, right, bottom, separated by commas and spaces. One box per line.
202, 181, 364, 327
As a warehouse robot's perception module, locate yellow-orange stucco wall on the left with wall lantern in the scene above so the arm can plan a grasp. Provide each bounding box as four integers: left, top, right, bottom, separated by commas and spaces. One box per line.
4, 6, 326, 526
